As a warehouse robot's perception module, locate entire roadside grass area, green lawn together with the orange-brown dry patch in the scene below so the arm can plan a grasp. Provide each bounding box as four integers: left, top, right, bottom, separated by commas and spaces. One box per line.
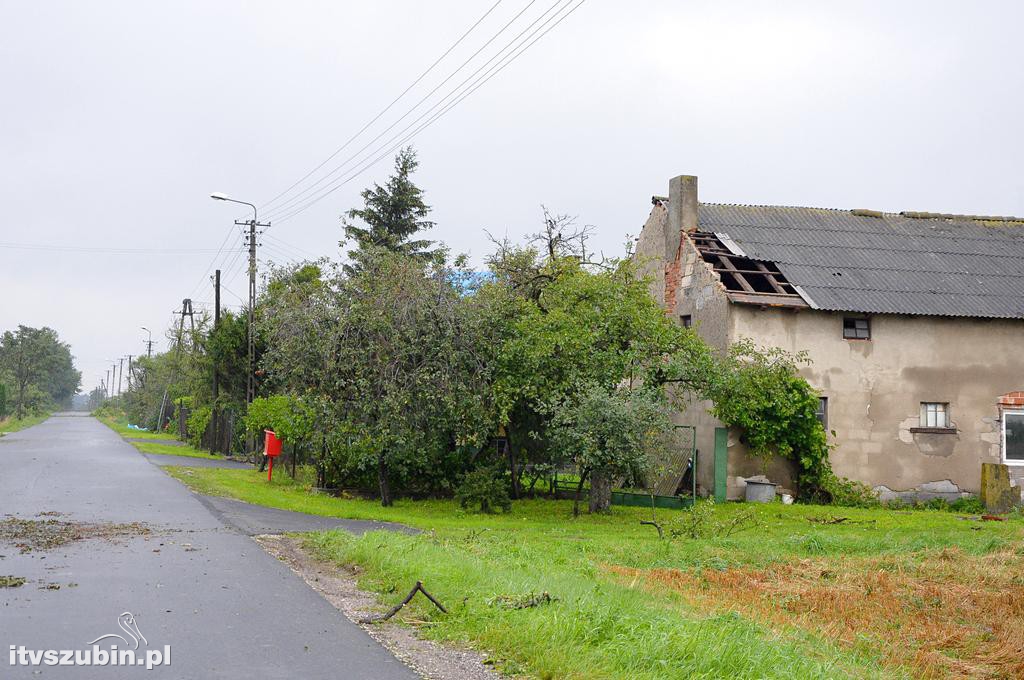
168, 469, 1024, 679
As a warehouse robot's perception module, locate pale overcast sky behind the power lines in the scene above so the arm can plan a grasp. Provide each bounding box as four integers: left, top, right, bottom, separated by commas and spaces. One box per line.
0, 0, 1024, 390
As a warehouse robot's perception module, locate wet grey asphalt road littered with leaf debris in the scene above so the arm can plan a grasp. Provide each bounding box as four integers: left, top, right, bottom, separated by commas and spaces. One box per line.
0, 417, 418, 680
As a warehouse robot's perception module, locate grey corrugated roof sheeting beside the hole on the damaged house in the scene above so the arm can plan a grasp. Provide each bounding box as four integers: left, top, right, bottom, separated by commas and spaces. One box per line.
698, 204, 1024, 318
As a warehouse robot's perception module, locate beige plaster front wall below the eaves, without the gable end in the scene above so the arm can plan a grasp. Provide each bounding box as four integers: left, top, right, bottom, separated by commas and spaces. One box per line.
729, 304, 1024, 496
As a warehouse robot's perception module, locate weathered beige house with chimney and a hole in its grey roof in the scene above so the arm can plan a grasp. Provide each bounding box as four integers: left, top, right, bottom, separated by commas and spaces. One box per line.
636, 176, 1024, 500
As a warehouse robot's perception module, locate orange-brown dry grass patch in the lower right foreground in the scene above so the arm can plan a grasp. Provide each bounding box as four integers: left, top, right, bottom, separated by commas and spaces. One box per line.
606, 548, 1024, 678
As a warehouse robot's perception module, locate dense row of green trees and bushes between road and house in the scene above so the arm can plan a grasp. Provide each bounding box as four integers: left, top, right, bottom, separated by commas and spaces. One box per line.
114, 148, 847, 511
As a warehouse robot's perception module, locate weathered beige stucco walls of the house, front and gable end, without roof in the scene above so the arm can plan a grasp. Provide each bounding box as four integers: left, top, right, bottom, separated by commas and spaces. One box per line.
636, 178, 1024, 498
